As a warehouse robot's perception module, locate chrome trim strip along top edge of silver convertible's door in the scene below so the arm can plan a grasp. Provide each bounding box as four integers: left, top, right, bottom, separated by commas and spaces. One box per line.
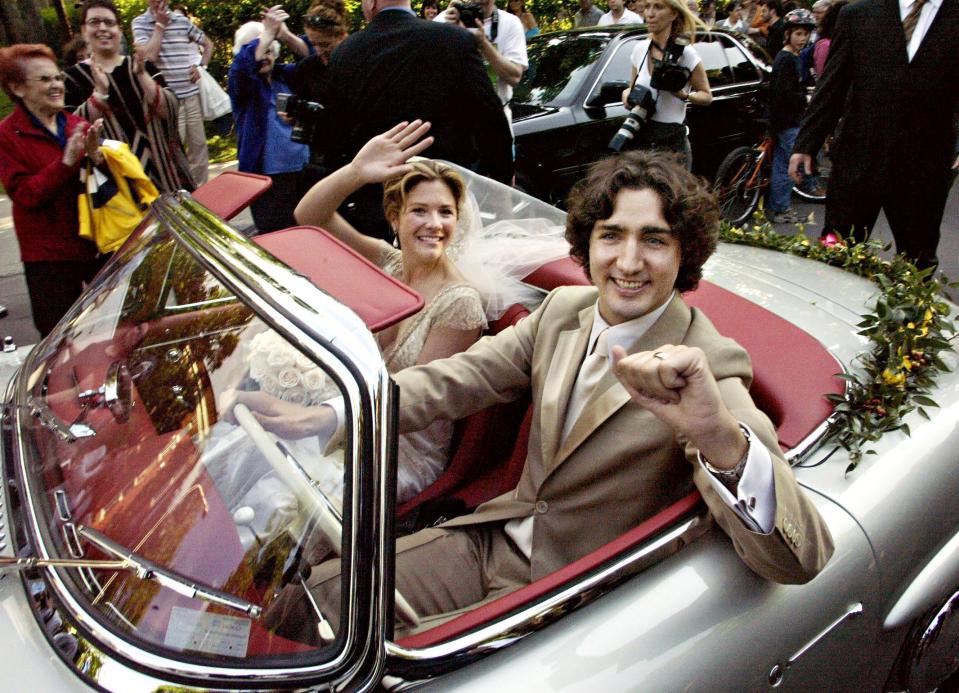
386, 507, 706, 680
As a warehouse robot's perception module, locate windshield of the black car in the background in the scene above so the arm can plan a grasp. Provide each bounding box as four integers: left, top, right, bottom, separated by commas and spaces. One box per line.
513, 33, 609, 106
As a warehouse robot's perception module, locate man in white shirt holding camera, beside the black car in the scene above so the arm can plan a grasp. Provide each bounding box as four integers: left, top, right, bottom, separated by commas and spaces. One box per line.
433, 0, 529, 121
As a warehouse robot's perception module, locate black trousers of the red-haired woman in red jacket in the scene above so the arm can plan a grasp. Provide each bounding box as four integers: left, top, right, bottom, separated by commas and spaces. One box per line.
23, 256, 107, 337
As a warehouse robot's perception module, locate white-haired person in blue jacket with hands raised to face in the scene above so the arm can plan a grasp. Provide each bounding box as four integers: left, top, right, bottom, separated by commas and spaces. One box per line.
227, 6, 310, 232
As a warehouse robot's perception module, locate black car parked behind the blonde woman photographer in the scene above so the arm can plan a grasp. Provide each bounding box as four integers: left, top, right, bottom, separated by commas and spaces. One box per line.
510, 24, 770, 203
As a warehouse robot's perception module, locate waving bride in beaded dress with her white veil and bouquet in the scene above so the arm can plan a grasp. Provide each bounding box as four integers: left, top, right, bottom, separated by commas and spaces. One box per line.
212, 121, 569, 528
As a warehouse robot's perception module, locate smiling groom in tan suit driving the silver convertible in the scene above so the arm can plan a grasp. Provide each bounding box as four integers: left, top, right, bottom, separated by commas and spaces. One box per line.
262, 152, 833, 642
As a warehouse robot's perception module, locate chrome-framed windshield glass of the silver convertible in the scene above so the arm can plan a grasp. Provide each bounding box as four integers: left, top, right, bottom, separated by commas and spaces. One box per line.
8, 215, 364, 666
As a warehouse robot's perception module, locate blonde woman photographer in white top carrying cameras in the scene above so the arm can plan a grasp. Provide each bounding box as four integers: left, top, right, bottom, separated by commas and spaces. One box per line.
609, 0, 713, 168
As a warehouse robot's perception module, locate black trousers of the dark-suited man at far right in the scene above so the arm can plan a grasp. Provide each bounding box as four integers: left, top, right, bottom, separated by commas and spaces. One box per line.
823, 168, 951, 269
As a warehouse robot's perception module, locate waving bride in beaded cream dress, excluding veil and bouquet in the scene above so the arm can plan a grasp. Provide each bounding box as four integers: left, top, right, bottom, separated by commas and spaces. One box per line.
295, 121, 486, 503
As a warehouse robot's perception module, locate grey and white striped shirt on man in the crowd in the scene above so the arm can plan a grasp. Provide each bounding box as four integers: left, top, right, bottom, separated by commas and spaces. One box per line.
133, 9, 204, 99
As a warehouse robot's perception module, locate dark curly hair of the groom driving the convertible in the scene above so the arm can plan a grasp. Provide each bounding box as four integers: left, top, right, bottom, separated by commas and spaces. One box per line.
566, 150, 719, 292
